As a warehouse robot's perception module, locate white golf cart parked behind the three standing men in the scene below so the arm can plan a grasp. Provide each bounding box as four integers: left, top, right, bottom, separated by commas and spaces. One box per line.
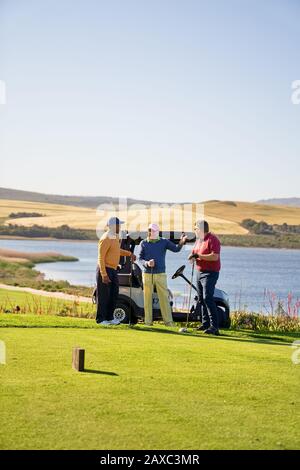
93, 231, 230, 328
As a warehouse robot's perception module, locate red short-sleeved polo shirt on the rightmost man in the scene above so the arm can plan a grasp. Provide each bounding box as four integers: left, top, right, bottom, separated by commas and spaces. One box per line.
192, 232, 221, 272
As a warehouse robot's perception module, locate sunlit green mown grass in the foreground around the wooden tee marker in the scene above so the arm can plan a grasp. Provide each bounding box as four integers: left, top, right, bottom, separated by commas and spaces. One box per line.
0, 314, 300, 450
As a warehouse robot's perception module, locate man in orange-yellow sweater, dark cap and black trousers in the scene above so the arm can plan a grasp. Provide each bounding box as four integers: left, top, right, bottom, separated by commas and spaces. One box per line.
96, 217, 135, 325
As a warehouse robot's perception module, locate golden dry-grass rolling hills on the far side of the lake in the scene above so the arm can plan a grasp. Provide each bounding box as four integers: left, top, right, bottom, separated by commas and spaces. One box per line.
0, 190, 300, 235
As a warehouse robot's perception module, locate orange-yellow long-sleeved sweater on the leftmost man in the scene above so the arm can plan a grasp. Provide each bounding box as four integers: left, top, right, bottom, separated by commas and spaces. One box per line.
98, 232, 131, 277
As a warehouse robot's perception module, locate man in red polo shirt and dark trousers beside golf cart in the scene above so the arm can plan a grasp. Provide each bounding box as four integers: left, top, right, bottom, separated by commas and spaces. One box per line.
189, 220, 221, 335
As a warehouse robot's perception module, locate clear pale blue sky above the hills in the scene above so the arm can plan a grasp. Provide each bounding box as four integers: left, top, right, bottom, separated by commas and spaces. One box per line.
0, 0, 300, 201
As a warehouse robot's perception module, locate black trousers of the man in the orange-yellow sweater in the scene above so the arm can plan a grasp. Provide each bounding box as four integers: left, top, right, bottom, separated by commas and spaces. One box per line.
96, 267, 119, 323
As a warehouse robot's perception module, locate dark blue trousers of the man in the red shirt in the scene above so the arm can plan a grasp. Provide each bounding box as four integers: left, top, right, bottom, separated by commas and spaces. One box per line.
197, 271, 219, 329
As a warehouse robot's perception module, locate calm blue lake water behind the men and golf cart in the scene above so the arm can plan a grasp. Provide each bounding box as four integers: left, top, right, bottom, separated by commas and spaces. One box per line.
0, 240, 300, 312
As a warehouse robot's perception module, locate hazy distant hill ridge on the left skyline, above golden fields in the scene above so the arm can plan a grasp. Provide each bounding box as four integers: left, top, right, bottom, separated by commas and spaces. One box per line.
0, 188, 175, 209
